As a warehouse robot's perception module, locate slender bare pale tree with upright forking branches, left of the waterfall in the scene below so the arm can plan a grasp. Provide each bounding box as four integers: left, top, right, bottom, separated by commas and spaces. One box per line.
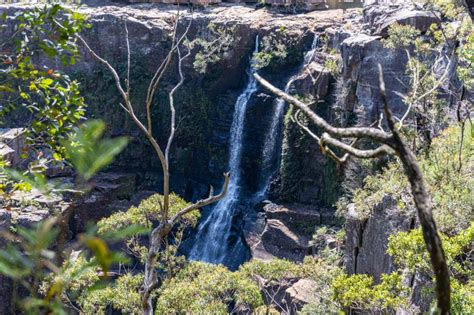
70, 12, 230, 314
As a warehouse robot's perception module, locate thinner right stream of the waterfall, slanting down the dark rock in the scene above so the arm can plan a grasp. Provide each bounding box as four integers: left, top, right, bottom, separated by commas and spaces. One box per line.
254, 34, 319, 200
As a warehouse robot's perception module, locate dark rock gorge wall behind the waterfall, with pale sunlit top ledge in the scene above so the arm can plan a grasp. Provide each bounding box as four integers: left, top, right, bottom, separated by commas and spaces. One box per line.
0, 4, 462, 313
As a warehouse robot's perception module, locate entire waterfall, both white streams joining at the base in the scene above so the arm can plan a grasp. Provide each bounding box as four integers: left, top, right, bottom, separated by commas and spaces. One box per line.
188, 35, 318, 269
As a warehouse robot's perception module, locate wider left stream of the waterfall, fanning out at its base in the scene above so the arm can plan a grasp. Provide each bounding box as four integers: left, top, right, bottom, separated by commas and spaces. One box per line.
189, 35, 258, 263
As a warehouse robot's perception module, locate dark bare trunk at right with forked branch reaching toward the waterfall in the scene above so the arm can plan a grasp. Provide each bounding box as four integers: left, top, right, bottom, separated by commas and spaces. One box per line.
254, 66, 451, 314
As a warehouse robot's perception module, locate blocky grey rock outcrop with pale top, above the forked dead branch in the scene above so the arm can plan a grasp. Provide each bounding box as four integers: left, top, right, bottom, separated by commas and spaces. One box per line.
337, 34, 408, 120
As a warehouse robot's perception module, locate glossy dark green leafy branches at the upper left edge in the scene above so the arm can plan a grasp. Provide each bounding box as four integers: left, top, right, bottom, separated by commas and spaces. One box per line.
0, 4, 88, 160
